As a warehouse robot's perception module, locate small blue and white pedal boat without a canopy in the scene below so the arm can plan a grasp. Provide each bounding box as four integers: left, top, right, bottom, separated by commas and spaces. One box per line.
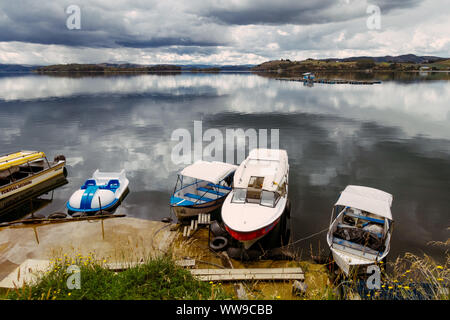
67, 169, 129, 213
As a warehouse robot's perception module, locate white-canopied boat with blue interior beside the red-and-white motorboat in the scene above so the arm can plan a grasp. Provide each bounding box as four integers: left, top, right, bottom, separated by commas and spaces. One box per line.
170, 161, 237, 219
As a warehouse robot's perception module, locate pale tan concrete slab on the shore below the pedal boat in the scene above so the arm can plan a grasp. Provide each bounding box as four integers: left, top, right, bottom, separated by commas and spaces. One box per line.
0, 217, 176, 280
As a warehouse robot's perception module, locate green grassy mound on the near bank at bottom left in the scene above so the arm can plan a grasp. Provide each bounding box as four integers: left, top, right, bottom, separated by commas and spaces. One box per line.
6, 255, 231, 300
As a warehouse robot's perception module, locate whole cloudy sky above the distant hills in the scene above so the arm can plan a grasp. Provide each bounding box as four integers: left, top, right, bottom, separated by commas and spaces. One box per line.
0, 0, 450, 65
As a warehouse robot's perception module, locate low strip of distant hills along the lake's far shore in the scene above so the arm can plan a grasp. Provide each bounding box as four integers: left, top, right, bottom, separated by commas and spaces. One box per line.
0, 54, 444, 75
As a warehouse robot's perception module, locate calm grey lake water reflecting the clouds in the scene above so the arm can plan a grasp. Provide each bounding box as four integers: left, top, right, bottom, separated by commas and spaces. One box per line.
0, 73, 450, 259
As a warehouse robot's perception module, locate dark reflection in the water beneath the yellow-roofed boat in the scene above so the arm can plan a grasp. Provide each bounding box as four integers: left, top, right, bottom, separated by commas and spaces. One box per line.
0, 175, 68, 221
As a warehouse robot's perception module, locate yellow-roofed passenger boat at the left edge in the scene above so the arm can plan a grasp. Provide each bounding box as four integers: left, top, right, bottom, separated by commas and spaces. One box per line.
0, 151, 66, 200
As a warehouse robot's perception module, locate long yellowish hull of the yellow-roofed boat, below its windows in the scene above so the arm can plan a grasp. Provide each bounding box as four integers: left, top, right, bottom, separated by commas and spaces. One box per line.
0, 161, 65, 201
